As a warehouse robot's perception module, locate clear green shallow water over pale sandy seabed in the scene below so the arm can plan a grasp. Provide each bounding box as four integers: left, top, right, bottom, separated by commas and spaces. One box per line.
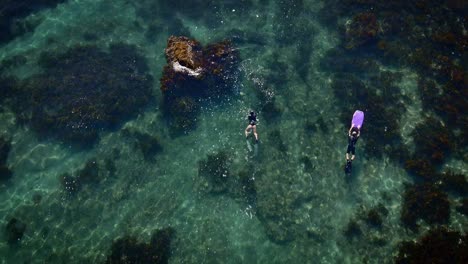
0, 0, 468, 263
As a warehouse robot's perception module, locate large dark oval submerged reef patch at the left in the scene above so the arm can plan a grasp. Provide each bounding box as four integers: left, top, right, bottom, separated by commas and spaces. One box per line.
13, 44, 152, 145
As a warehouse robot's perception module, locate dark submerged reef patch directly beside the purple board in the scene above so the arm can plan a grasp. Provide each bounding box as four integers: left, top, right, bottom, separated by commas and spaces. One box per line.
331, 72, 408, 162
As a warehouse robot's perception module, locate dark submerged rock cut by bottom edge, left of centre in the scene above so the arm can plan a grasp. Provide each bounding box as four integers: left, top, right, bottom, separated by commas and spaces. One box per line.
105, 227, 175, 264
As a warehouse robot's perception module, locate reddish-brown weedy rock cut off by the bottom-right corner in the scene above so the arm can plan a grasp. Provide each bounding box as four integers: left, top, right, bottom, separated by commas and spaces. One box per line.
395, 228, 468, 264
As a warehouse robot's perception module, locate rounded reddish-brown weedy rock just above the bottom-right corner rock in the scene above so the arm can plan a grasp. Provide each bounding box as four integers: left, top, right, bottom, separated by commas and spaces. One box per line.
401, 183, 450, 229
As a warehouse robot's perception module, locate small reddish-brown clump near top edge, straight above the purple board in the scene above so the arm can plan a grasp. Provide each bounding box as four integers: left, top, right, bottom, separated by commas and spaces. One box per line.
346, 12, 379, 49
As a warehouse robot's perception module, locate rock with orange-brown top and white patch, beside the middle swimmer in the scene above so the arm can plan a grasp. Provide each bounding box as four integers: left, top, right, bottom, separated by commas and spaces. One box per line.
160, 36, 238, 133
